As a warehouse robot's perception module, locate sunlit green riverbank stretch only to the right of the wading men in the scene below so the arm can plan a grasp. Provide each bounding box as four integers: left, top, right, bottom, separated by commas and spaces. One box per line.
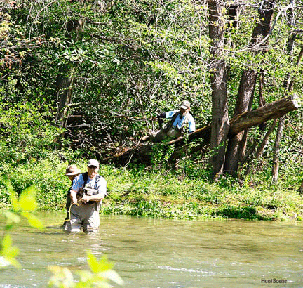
102, 166, 303, 221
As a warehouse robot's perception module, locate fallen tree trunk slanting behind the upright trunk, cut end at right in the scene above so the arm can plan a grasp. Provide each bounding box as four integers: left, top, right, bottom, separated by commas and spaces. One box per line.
105, 96, 299, 165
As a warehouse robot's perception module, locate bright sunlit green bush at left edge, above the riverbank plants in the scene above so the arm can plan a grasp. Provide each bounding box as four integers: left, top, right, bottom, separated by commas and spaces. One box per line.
0, 99, 60, 165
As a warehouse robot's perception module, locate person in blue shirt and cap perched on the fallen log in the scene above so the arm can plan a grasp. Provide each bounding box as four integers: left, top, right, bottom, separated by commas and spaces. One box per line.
142, 100, 196, 143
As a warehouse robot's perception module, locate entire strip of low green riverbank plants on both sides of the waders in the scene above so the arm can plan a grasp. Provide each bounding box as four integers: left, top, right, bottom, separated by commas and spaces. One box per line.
0, 159, 303, 221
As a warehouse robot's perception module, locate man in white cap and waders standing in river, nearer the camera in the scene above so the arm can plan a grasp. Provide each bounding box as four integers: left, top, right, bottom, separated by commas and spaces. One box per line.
65, 159, 107, 233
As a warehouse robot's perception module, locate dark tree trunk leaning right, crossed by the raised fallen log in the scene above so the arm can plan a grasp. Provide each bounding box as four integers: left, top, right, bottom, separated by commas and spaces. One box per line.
224, 1, 274, 175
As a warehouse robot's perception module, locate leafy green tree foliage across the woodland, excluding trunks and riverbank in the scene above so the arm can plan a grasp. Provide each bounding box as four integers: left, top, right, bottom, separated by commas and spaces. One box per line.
0, 0, 303, 178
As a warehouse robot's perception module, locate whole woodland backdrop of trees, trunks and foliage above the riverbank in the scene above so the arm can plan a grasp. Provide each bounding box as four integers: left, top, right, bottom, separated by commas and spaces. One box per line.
0, 0, 303, 217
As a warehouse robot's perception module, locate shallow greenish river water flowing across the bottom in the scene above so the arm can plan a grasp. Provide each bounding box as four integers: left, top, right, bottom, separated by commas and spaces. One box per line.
0, 213, 303, 288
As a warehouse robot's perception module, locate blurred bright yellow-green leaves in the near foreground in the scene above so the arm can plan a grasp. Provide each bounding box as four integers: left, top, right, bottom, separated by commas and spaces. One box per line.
0, 181, 123, 288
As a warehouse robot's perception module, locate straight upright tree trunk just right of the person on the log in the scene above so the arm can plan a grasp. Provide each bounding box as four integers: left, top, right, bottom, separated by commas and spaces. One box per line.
208, 0, 229, 177
